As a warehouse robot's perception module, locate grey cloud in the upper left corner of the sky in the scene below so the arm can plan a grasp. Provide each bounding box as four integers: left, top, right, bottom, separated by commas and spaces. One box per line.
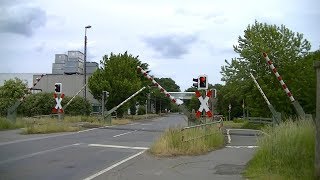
0, 4, 47, 36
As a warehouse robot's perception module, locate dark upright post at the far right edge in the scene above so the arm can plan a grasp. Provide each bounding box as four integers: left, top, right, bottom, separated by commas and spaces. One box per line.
314, 61, 320, 179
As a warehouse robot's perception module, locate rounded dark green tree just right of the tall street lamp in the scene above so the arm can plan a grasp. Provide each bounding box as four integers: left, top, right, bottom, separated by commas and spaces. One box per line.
88, 52, 148, 116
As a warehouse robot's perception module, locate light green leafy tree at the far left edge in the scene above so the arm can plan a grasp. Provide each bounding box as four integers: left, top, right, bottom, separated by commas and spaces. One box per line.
0, 78, 28, 116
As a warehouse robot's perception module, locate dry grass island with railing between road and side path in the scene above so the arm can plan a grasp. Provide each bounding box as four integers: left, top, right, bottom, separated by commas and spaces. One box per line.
148, 127, 224, 156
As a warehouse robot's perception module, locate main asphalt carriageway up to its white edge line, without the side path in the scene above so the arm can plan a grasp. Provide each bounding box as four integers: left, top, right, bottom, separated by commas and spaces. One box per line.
0, 115, 186, 180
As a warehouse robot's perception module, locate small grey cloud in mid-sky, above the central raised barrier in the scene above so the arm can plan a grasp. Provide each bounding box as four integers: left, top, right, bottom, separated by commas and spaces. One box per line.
144, 34, 198, 59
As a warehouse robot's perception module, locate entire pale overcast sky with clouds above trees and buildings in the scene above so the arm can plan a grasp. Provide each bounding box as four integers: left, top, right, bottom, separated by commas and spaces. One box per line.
0, 0, 320, 90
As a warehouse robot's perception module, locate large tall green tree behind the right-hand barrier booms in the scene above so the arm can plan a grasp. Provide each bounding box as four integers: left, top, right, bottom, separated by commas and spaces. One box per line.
219, 21, 311, 116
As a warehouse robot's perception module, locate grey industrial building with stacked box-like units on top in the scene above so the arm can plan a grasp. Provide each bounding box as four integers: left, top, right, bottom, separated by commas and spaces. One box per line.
33, 51, 102, 109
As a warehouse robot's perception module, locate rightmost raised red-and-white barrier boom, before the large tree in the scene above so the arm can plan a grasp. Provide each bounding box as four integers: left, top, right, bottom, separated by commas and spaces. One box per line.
263, 53, 305, 118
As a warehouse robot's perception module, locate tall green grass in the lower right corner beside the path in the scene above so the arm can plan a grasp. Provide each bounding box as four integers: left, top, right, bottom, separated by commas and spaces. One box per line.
245, 120, 315, 179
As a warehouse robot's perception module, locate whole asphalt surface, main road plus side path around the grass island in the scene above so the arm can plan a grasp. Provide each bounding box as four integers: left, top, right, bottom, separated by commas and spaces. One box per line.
0, 114, 256, 180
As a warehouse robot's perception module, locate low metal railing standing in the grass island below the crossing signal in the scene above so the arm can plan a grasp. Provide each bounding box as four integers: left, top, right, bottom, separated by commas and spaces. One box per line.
181, 118, 223, 142
